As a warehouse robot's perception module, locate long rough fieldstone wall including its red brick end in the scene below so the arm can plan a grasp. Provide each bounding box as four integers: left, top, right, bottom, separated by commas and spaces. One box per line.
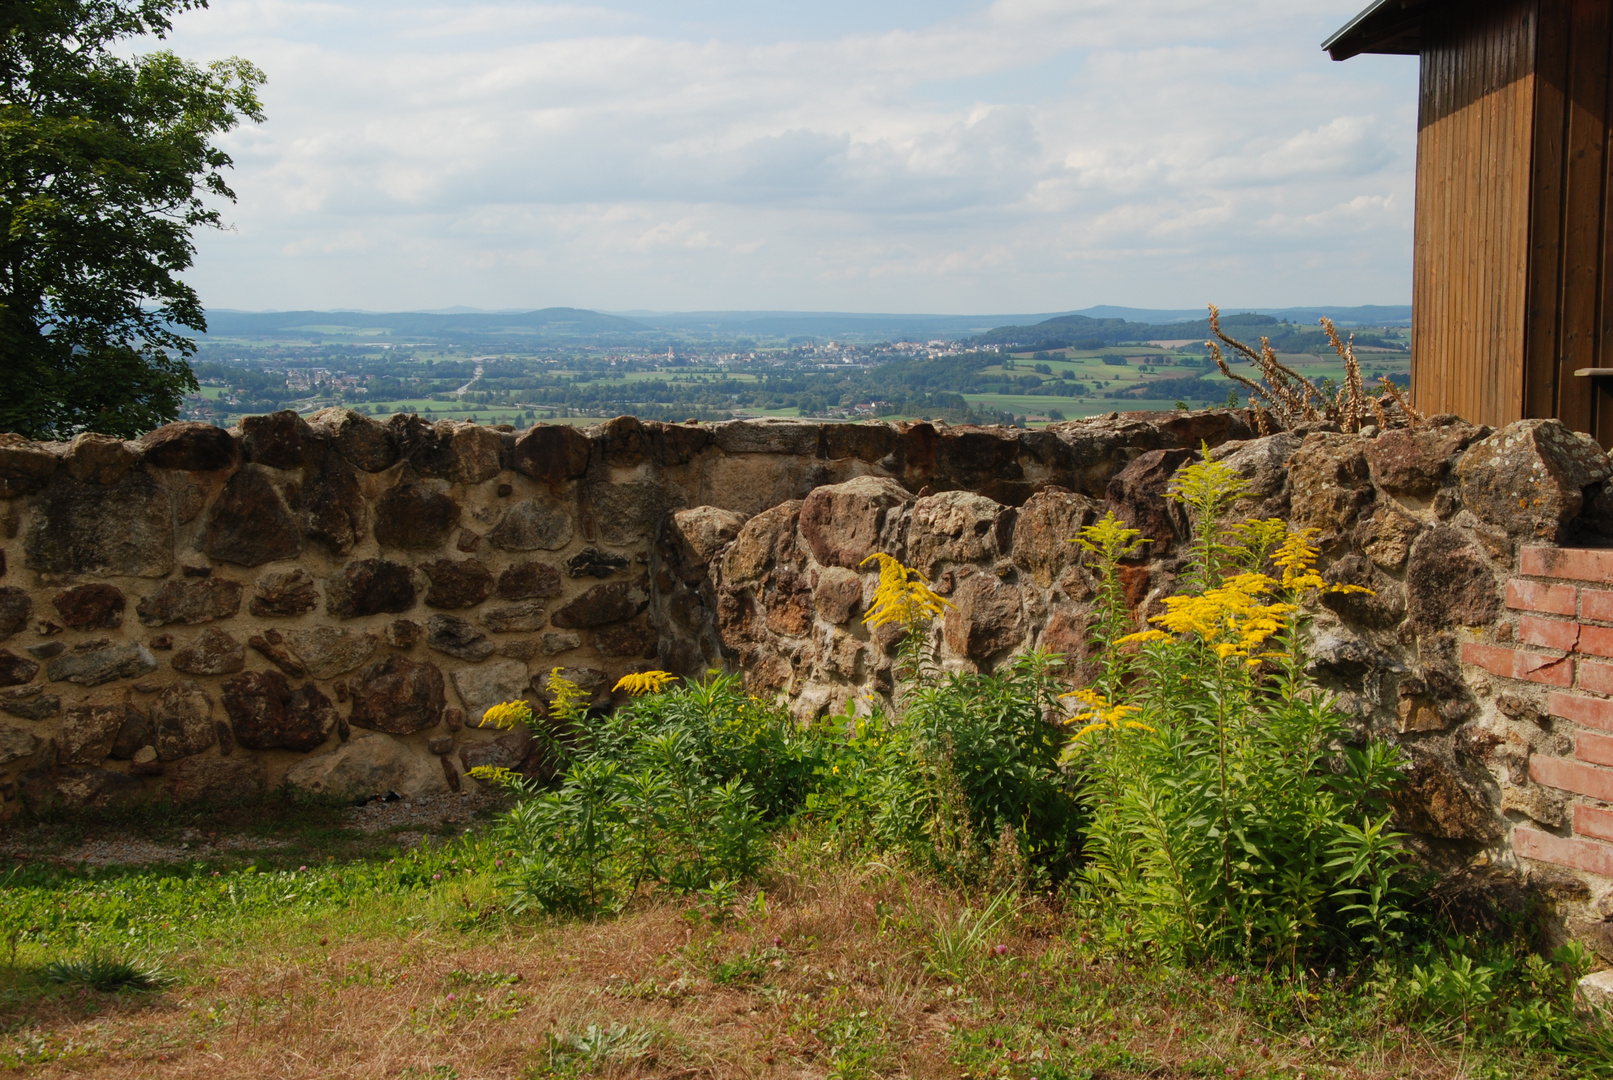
9, 409, 1613, 956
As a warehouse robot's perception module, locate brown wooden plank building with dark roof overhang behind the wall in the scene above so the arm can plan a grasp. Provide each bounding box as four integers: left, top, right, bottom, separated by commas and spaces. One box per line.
1323, 0, 1613, 447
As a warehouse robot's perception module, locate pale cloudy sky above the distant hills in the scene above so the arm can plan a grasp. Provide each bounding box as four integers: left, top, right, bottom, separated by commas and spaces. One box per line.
171, 0, 1416, 313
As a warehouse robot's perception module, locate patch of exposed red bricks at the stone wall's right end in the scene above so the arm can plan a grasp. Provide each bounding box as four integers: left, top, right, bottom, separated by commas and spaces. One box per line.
1461, 546, 1613, 877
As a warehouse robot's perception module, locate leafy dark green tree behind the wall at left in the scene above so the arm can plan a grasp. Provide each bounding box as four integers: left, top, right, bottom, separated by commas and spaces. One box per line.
0, 0, 263, 438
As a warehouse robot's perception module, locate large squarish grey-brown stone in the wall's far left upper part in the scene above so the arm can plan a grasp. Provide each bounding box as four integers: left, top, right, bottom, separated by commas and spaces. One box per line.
23, 470, 175, 577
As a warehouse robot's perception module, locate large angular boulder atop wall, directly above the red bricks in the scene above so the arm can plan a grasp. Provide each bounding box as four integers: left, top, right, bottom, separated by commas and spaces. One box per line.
1457, 421, 1613, 543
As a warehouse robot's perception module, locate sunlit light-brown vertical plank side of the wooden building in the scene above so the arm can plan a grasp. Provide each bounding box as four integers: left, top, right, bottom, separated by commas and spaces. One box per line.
1411, 0, 1535, 424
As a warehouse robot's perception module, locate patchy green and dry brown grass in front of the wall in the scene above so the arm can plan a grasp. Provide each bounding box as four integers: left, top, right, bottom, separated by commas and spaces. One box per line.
0, 808, 1592, 1080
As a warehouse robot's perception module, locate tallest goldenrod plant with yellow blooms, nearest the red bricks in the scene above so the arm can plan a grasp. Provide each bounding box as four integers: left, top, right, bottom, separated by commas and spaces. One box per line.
1066, 461, 1407, 969
